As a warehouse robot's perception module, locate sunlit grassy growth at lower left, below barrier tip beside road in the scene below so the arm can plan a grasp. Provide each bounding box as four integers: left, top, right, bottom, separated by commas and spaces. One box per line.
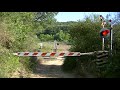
0, 46, 37, 78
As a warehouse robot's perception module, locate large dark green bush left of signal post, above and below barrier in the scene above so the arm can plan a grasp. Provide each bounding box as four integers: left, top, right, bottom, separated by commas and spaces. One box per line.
64, 14, 112, 76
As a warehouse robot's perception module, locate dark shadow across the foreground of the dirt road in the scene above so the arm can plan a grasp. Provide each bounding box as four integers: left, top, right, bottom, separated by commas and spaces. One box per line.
31, 61, 80, 78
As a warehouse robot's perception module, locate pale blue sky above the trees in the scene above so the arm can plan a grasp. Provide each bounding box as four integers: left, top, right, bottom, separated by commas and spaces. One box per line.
55, 12, 114, 22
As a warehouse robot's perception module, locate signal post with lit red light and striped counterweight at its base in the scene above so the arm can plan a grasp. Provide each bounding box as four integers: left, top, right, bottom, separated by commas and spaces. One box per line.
96, 15, 113, 67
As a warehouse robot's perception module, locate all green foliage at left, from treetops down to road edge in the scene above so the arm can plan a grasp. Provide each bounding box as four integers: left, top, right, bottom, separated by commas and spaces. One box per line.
0, 12, 57, 77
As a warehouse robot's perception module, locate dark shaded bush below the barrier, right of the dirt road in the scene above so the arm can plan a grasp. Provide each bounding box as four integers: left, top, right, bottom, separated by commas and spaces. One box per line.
62, 53, 97, 76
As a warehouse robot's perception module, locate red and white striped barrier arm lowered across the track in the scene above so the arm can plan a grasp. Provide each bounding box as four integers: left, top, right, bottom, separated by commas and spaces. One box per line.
13, 52, 80, 57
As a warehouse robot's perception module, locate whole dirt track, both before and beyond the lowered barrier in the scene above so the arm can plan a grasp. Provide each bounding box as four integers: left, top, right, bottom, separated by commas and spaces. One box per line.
15, 42, 94, 78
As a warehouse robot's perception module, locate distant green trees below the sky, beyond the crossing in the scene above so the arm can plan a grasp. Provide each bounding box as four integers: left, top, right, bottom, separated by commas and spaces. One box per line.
37, 22, 71, 42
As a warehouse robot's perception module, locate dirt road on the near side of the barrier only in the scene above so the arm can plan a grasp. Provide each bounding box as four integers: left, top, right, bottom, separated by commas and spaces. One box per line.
30, 60, 80, 78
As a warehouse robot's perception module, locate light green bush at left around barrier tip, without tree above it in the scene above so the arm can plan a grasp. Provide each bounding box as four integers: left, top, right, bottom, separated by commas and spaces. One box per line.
0, 15, 39, 78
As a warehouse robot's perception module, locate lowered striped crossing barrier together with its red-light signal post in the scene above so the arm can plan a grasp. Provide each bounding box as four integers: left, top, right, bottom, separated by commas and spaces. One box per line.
13, 15, 113, 66
